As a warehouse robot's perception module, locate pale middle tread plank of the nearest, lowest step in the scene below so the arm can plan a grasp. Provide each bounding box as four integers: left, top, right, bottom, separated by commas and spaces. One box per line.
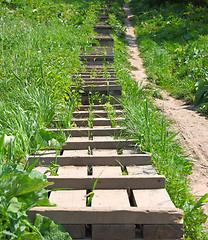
92, 190, 130, 209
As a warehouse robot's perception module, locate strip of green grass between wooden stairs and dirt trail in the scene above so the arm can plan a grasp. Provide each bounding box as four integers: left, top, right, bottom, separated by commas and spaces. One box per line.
109, 1, 208, 240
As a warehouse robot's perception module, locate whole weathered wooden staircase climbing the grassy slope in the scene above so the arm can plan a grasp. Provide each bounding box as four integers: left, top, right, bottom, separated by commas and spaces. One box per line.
28, 9, 183, 240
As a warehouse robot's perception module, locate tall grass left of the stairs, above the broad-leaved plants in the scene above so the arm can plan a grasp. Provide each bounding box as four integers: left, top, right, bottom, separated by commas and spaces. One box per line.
0, 0, 100, 160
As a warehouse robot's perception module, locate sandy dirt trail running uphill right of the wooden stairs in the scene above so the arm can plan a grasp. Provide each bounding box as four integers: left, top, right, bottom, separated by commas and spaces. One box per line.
124, 4, 208, 220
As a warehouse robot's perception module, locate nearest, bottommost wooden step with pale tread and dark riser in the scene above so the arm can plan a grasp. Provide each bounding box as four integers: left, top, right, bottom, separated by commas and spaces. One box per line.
28, 189, 183, 240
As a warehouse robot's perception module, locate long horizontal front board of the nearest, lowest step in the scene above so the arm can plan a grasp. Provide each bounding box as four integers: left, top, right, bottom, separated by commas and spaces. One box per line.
27, 207, 183, 225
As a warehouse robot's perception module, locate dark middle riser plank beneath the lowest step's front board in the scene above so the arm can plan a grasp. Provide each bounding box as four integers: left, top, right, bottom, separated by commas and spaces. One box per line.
92, 224, 135, 240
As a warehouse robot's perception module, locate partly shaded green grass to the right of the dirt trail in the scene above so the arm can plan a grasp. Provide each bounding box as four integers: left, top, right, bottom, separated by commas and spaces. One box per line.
130, 0, 208, 113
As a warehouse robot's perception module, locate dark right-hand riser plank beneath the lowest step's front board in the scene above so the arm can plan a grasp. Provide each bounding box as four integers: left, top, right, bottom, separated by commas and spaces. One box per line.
143, 224, 184, 240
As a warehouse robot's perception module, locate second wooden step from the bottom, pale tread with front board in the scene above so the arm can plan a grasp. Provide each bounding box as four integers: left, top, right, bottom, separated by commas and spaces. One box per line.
35, 165, 165, 189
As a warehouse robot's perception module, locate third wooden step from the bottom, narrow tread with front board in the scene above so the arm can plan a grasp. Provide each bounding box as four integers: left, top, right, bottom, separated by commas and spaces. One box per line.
28, 149, 152, 167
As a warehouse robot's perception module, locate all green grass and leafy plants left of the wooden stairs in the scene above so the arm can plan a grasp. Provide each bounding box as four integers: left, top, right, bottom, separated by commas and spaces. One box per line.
0, 0, 102, 240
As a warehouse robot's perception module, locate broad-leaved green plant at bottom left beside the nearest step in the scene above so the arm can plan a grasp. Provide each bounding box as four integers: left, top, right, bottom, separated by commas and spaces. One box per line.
0, 163, 69, 239
